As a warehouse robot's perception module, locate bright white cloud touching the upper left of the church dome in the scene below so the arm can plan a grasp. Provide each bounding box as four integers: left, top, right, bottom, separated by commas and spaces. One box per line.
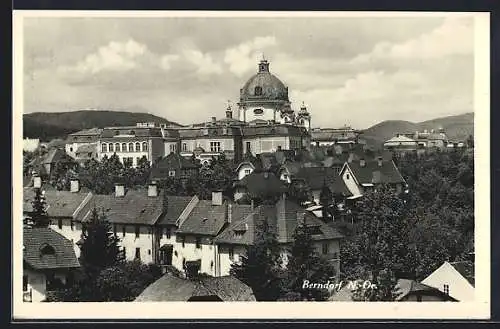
224, 36, 276, 77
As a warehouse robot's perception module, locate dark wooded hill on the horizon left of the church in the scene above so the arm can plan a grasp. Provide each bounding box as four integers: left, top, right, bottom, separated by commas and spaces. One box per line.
23, 110, 181, 141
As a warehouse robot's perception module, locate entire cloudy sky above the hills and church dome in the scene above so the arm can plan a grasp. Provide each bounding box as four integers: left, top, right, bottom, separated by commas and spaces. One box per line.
24, 16, 474, 129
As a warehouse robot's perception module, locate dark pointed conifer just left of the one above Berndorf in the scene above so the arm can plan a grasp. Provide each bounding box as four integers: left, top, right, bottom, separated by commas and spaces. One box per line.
230, 220, 283, 301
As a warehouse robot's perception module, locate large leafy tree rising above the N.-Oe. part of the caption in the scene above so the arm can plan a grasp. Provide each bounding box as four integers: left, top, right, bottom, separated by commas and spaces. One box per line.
341, 186, 417, 301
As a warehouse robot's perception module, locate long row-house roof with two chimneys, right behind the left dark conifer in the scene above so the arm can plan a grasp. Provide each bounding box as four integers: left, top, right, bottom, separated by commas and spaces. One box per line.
76, 189, 163, 225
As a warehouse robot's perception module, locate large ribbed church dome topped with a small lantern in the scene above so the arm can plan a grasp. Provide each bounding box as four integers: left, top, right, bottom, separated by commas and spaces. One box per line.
240, 60, 288, 102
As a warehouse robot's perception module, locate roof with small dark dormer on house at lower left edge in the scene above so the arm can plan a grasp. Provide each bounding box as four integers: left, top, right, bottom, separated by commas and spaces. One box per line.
23, 227, 80, 270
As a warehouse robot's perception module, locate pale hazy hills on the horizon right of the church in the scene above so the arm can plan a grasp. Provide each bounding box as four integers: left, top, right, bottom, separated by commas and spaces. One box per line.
363, 113, 474, 148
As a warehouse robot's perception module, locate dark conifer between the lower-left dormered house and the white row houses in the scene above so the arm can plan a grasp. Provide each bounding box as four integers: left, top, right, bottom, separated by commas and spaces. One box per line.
80, 208, 123, 277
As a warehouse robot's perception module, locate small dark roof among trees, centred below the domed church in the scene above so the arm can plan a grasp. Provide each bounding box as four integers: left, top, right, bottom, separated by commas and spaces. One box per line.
235, 171, 287, 196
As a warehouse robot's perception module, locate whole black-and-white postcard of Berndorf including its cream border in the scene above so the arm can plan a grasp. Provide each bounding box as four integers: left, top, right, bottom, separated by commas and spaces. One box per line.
12, 11, 490, 319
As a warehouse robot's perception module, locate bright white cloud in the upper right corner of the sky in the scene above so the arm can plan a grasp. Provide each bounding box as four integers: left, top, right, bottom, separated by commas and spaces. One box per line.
351, 17, 474, 64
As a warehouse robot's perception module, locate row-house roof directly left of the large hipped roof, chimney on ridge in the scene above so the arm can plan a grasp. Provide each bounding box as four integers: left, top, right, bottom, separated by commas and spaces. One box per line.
177, 200, 251, 236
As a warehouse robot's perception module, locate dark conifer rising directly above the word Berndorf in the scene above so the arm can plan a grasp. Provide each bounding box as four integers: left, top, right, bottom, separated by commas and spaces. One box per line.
285, 218, 336, 301
